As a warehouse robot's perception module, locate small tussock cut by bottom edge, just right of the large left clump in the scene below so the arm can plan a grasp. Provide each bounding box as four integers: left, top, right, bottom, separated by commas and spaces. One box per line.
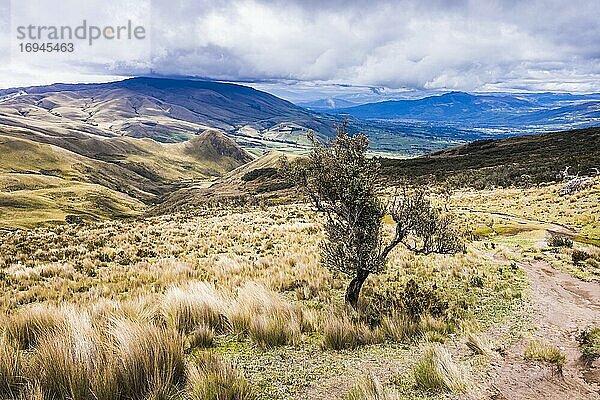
188, 352, 256, 400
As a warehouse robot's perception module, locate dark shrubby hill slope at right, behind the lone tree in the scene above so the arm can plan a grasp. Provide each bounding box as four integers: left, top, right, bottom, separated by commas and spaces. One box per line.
380, 128, 600, 187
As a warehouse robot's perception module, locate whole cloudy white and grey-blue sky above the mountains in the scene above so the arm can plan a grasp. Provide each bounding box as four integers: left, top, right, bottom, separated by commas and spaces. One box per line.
0, 0, 600, 97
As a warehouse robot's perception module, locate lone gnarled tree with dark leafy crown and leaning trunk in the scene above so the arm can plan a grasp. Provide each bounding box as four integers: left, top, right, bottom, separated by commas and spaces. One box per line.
284, 122, 464, 309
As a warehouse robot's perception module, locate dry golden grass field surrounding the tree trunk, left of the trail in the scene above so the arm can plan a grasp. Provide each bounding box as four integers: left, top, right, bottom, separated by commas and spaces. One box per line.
0, 205, 540, 399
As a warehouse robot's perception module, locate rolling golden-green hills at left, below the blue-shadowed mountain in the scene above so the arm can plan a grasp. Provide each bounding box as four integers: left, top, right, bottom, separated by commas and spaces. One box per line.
0, 131, 251, 229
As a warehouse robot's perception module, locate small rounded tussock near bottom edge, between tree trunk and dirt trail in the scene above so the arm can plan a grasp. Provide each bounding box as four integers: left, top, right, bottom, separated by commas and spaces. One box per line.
413, 345, 469, 393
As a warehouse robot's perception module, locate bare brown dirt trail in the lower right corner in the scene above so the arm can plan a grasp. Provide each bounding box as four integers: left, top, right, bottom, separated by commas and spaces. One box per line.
492, 261, 600, 400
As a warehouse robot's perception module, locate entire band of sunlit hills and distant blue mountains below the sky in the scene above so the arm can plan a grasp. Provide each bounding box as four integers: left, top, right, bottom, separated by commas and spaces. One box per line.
0, 78, 600, 227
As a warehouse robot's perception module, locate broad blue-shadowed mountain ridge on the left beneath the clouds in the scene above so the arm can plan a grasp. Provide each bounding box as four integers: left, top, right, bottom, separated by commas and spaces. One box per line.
0, 77, 333, 147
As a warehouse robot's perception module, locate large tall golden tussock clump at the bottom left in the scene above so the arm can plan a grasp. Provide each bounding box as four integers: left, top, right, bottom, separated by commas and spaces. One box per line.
13, 307, 187, 400
